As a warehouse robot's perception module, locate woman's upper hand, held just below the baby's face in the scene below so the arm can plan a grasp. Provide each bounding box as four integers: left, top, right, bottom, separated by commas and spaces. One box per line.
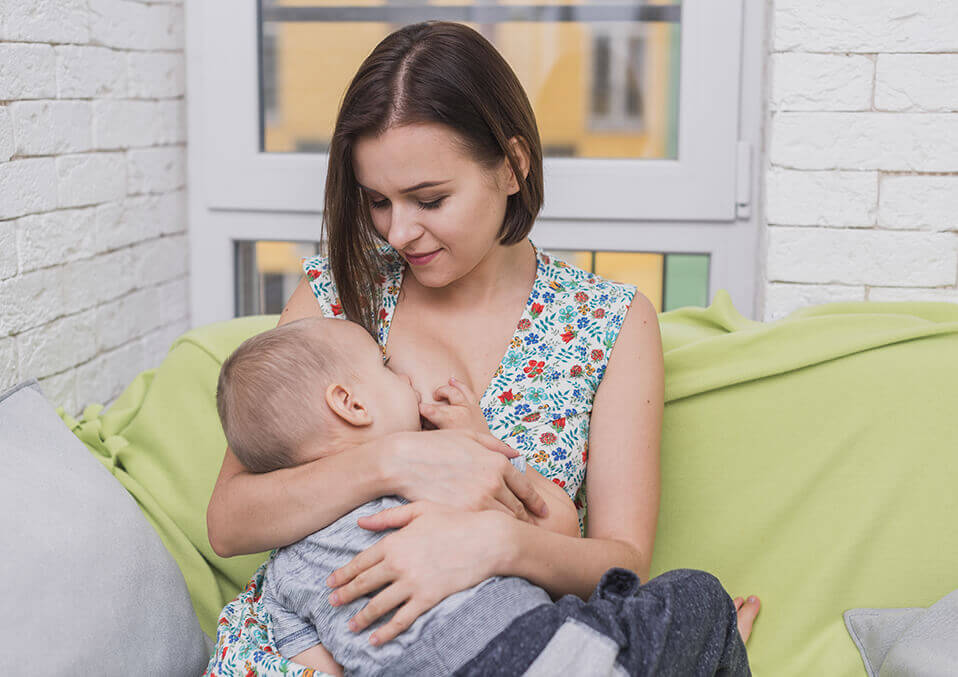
387, 430, 549, 522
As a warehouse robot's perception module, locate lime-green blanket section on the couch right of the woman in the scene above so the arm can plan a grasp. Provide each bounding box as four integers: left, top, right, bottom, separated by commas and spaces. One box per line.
652, 292, 958, 677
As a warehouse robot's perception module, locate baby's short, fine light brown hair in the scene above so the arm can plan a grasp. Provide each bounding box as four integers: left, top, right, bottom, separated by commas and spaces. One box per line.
216, 317, 347, 472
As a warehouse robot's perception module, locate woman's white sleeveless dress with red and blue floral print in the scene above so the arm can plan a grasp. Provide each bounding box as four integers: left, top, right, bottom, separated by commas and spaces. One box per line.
205, 240, 636, 677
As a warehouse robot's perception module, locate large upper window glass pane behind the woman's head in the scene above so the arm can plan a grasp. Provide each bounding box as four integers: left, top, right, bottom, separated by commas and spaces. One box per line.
259, 0, 682, 159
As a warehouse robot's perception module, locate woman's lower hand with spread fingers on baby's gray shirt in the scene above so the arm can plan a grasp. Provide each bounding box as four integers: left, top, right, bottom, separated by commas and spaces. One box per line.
326, 501, 511, 644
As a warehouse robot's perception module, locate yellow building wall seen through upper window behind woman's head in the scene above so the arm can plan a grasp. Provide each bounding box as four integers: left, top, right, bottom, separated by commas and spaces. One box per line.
265, 11, 672, 158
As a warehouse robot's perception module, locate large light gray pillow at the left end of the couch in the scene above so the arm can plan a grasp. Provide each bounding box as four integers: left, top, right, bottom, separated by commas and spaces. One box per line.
0, 379, 211, 675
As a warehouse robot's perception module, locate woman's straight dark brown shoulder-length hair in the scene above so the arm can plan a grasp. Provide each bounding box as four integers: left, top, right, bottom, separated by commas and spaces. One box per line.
323, 21, 543, 337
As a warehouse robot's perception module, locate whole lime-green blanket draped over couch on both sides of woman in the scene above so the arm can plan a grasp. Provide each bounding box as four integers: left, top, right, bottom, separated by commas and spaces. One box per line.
58, 291, 958, 677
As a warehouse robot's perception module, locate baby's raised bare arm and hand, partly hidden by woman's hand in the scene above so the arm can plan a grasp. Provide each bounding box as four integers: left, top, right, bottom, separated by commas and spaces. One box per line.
419, 378, 581, 538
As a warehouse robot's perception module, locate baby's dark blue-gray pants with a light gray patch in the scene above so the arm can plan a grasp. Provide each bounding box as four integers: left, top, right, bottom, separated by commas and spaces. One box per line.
455, 567, 751, 677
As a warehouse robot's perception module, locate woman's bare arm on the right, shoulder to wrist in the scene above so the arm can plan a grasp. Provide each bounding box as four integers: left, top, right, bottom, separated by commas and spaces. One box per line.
493, 293, 665, 599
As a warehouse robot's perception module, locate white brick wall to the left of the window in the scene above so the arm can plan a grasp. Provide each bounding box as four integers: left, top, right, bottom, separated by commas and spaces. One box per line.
0, 0, 189, 414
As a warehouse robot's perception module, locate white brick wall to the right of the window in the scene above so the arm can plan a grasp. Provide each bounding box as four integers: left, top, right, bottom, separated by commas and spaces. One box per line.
762, 0, 958, 320
